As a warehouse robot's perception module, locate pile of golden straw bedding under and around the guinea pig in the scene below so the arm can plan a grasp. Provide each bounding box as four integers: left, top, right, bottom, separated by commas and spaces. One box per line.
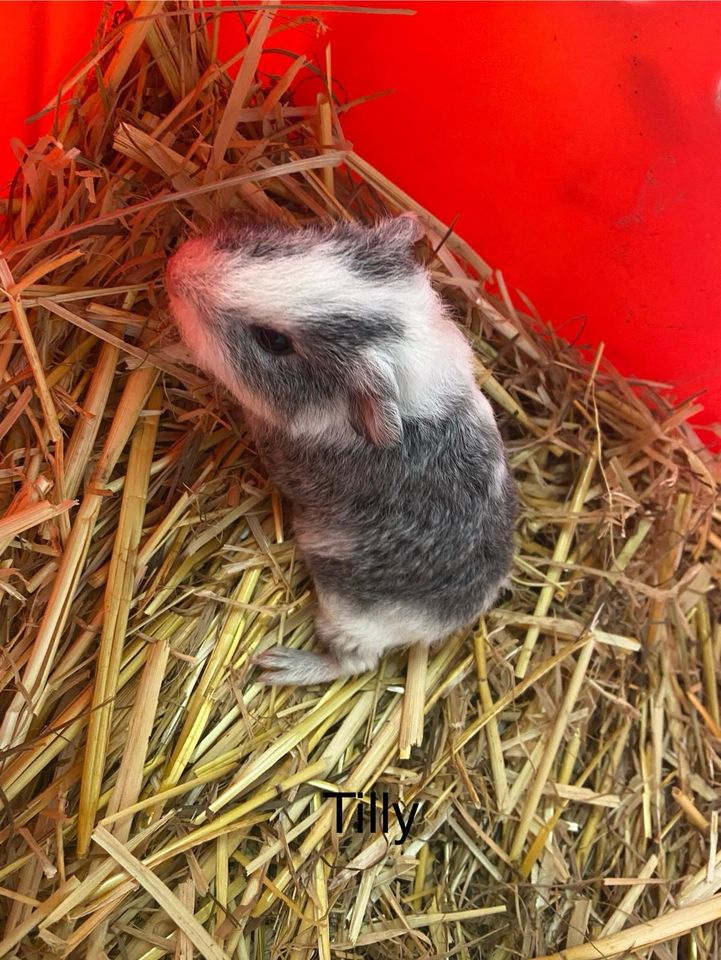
0, 2, 721, 960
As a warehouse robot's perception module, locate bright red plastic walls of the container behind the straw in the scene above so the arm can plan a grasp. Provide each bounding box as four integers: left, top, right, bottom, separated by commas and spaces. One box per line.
0, 0, 721, 437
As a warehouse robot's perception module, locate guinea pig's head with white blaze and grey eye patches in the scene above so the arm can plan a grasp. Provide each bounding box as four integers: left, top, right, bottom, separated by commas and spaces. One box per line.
166, 215, 435, 446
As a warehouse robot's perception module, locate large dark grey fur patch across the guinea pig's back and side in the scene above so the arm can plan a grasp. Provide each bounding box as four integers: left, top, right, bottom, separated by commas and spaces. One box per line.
256, 400, 517, 632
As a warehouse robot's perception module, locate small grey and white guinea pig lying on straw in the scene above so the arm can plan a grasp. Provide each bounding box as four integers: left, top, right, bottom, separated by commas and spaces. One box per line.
167, 215, 516, 684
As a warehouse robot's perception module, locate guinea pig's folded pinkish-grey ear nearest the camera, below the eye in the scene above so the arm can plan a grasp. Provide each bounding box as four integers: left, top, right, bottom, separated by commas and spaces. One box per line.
348, 360, 403, 447
